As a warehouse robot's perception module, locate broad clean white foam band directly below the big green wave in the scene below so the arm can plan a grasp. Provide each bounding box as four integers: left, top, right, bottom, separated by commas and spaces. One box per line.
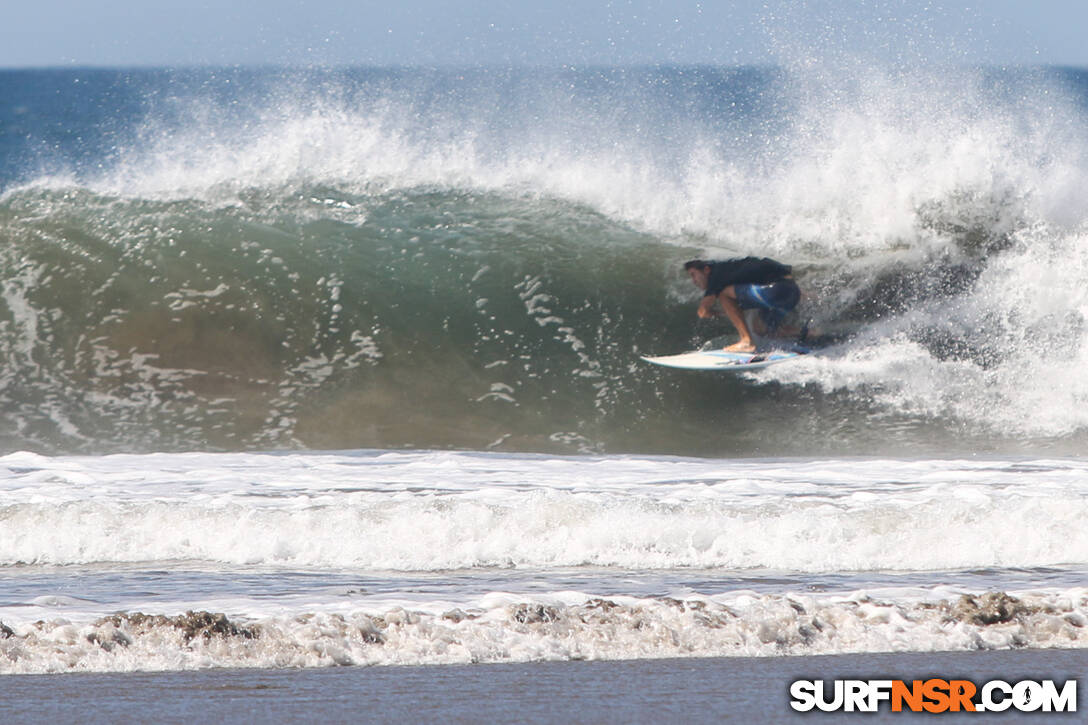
0, 453, 1088, 573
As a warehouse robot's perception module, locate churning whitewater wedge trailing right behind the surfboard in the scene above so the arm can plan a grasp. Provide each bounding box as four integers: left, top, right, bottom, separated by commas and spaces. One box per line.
761, 219, 1088, 438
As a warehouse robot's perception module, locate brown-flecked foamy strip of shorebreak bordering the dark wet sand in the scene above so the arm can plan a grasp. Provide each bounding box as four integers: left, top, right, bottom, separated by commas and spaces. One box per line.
0, 589, 1088, 674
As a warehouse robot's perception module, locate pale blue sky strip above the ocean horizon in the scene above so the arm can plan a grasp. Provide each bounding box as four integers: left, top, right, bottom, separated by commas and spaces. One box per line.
0, 0, 1088, 67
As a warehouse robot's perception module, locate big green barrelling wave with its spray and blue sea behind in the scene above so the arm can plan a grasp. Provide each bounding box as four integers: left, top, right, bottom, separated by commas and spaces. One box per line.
0, 69, 1088, 455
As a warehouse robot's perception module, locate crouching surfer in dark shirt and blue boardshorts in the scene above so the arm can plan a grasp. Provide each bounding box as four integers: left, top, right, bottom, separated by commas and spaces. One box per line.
683, 257, 801, 353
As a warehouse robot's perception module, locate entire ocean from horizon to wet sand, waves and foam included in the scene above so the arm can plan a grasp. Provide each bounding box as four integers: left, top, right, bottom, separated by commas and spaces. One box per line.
0, 67, 1088, 674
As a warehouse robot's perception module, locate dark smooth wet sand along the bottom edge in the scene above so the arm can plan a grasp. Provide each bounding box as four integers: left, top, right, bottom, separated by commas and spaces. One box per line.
0, 650, 1088, 725
